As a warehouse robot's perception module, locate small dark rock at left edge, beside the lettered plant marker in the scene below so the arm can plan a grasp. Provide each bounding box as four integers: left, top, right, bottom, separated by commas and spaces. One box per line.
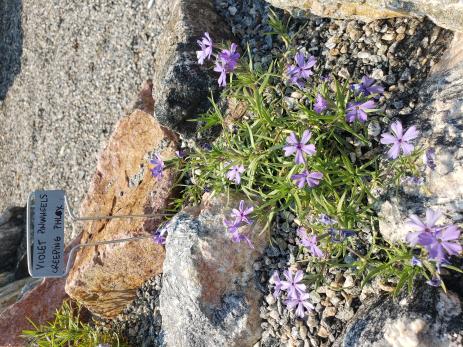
0, 207, 26, 272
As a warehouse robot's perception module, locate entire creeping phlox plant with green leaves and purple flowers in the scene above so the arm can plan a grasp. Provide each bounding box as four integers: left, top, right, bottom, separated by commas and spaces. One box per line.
148, 23, 461, 317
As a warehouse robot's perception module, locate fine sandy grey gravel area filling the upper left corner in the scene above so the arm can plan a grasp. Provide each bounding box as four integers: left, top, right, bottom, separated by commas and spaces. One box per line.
0, 0, 168, 211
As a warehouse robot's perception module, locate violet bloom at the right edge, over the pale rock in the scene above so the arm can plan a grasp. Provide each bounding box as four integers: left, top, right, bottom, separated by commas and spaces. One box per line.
418, 225, 462, 262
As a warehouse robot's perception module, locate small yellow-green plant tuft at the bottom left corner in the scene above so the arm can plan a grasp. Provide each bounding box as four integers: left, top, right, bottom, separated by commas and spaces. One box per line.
23, 302, 127, 347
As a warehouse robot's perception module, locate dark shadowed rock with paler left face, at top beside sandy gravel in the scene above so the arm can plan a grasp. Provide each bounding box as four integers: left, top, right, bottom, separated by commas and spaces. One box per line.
153, 0, 230, 135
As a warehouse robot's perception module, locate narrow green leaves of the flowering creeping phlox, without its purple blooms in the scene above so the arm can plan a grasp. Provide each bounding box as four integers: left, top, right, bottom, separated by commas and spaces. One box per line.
172, 21, 452, 295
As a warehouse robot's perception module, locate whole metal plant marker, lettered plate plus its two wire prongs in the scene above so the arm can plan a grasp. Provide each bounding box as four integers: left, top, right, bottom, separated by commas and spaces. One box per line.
26, 190, 170, 278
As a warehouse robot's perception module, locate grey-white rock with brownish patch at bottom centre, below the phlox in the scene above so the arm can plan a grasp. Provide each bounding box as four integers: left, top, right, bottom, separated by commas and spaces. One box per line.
160, 197, 266, 347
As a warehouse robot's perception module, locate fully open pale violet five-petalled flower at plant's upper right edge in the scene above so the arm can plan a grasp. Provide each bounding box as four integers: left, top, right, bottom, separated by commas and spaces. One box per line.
381, 121, 419, 159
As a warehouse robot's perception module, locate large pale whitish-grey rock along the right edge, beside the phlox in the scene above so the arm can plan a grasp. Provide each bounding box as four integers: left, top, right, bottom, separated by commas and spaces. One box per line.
378, 34, 463, 241
